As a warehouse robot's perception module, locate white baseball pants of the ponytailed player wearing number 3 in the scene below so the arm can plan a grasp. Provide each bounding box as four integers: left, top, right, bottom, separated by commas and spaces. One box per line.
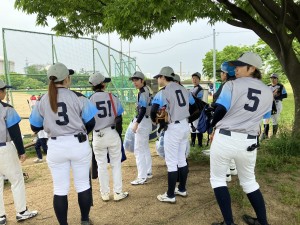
47, 135, 92, 196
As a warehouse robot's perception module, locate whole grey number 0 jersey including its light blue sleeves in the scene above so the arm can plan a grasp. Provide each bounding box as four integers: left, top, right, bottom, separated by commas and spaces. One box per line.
152, 82, 195, 123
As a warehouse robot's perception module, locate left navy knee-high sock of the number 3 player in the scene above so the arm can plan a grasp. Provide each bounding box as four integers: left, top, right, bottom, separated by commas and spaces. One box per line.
53, 195, 68, 225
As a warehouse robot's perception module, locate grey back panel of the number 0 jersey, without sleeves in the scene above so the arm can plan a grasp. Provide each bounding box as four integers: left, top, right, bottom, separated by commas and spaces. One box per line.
162, 82, 190, 123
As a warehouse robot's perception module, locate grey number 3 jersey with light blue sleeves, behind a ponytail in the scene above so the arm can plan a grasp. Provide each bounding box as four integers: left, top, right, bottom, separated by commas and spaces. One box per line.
29, 88, 97, 137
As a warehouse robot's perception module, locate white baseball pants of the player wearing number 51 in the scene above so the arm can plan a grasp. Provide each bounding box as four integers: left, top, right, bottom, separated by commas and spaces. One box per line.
93, 127, 122, 194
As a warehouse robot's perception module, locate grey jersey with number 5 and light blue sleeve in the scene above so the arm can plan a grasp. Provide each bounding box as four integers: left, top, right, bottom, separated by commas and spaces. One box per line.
216, 77, 273, 136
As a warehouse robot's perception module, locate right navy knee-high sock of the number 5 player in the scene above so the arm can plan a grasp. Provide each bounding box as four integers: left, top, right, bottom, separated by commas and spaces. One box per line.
247, 189, 268, 225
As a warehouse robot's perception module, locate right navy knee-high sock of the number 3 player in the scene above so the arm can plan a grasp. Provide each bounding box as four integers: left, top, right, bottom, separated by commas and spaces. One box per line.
78, 188, 92, 221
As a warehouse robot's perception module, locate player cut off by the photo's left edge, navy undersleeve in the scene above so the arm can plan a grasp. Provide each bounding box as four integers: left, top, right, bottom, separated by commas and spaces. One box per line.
0, 80, 38, 224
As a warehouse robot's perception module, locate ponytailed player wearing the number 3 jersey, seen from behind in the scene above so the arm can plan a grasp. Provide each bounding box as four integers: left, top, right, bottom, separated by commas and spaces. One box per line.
29, 63, 98, 225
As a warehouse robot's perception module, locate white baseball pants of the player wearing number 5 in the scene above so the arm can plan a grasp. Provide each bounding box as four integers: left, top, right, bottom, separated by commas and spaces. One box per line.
210, 129, 259, 194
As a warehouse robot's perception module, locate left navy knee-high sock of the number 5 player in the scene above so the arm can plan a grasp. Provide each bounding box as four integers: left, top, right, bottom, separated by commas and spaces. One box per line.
214, 187, 233, 224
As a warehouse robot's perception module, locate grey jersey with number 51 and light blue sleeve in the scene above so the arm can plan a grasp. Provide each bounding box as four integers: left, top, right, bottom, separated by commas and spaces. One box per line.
90, 92, 124, 130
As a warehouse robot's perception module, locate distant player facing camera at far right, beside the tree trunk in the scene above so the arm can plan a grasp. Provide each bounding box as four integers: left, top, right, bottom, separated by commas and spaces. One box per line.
262, 73, 287, 139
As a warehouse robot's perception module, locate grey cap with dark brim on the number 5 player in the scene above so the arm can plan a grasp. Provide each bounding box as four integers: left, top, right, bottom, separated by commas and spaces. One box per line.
229, 52, 262, 69
